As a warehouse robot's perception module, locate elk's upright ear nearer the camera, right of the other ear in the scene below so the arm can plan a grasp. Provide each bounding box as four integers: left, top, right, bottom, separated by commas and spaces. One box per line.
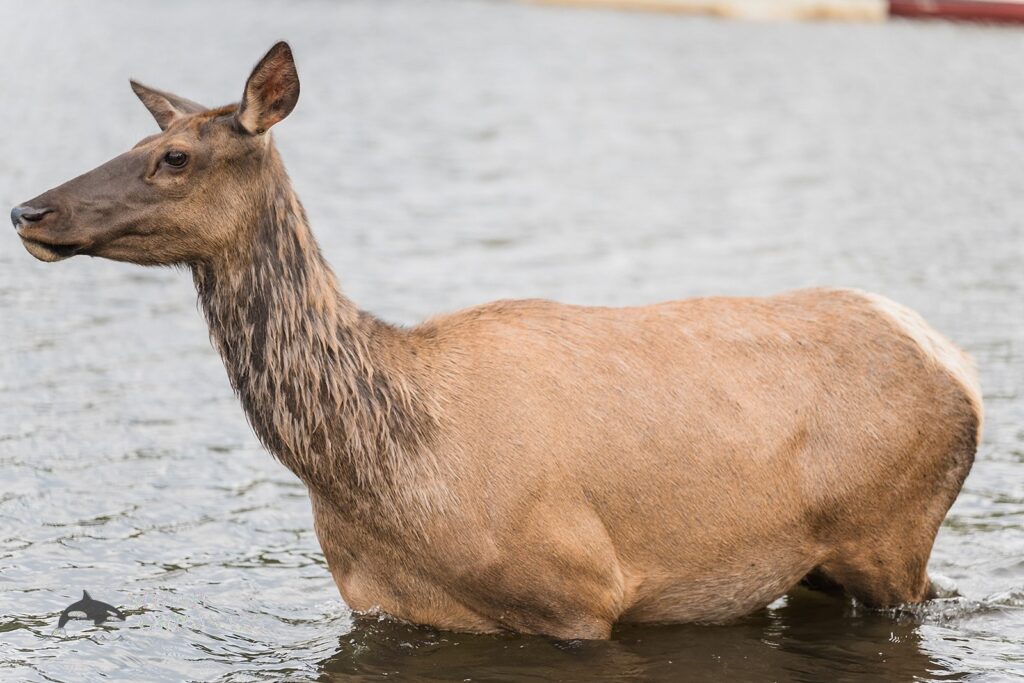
234, 41, 299, 135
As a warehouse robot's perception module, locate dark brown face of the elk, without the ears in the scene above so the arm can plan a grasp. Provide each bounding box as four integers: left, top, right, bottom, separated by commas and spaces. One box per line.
11, 114, 254, 265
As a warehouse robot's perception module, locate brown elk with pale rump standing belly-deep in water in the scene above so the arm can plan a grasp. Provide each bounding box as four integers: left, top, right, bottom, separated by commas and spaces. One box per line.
11, 42, 982, 639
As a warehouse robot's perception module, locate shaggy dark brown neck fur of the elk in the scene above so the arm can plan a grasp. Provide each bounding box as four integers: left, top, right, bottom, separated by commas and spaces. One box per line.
193, 155, 433, 504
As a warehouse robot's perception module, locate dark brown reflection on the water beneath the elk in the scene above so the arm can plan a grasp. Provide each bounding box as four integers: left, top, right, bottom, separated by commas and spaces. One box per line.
322, 589, 963, 681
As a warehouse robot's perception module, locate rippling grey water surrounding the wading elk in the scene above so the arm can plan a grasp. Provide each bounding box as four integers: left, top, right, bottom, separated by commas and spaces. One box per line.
0, 0, 1024, 681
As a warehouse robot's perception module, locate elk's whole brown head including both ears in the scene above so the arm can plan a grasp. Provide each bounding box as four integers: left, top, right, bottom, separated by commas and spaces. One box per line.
10, 43, 299, 265
